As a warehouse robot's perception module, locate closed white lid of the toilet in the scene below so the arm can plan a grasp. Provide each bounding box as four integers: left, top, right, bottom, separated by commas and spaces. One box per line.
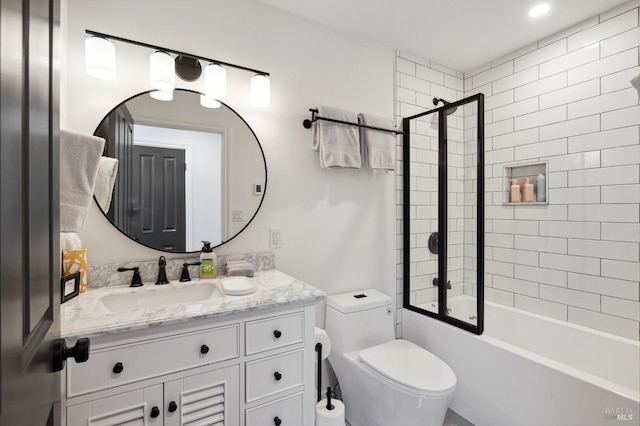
359, 339, 456, 396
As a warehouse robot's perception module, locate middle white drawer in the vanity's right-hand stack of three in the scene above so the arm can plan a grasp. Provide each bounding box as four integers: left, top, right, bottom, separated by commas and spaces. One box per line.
246, 349, 303, 402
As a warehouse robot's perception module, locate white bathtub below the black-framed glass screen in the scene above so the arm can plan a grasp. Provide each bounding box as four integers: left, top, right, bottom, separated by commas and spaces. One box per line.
402, 296, 640, 426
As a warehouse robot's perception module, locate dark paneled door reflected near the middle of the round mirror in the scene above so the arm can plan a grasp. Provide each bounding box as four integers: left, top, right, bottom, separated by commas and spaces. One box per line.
131, 145, 186, 251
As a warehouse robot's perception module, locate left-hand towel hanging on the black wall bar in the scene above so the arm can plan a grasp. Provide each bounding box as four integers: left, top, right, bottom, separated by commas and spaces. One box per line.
312, 106, 361, 169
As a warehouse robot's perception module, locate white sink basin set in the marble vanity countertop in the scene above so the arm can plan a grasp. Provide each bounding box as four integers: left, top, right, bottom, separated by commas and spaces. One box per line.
100, 283, 224, 312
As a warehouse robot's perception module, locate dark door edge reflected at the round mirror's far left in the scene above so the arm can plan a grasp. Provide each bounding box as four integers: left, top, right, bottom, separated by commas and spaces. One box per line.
96, 105, 134, 235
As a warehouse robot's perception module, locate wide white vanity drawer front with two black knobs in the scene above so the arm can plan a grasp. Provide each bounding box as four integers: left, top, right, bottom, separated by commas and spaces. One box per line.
67, 324, 240, 397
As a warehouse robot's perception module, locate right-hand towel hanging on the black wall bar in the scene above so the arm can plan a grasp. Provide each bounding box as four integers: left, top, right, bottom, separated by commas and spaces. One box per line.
358, 113, 396, 170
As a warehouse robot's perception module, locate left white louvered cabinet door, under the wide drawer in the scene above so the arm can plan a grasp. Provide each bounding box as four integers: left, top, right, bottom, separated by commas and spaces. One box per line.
67, 385, 164, 426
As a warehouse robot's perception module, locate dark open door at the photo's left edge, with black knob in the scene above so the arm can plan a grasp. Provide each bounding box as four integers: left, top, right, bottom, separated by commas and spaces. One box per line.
0, 0, 60, 426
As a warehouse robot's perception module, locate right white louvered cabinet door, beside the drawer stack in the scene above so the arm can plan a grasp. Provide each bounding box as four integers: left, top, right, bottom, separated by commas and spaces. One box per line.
164, 365, 240, 426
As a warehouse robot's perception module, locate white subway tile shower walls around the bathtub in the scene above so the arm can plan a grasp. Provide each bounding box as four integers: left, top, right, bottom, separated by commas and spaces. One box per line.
396, 0, 640, 340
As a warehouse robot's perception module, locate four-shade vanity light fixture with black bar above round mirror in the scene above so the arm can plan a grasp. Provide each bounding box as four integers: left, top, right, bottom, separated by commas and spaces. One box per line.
85, 30, 271, 108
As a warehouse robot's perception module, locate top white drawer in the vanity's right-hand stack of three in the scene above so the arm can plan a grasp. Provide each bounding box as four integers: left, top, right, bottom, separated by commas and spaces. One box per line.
246, 312, 304, 355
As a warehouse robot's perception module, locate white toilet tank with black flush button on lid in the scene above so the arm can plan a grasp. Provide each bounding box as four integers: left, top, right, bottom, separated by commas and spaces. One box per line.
326, 289, 396, 354
